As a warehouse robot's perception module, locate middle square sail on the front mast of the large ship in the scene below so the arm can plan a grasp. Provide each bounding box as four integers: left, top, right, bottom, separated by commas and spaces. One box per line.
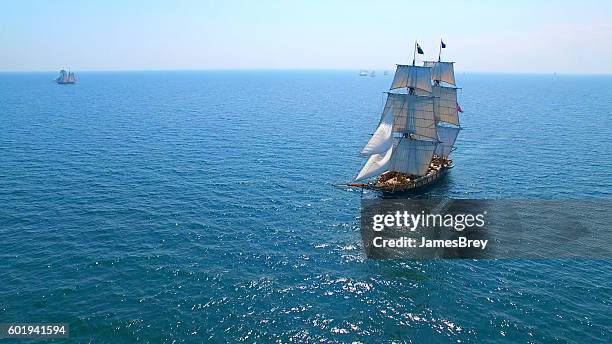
383, 91, 438, 140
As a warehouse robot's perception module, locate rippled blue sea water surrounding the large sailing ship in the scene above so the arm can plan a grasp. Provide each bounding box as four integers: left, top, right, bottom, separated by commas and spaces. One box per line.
0, 71, 612, 343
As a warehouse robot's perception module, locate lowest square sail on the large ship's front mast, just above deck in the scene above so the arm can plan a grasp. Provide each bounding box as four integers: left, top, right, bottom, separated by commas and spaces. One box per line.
391, 138, 437, 176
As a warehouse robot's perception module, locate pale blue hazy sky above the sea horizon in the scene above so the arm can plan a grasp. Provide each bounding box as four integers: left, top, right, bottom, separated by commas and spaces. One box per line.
0, 0, 612, 74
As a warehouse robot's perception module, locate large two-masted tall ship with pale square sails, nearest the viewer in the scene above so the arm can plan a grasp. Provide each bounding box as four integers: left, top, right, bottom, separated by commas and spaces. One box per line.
344, 40, 463, 193
